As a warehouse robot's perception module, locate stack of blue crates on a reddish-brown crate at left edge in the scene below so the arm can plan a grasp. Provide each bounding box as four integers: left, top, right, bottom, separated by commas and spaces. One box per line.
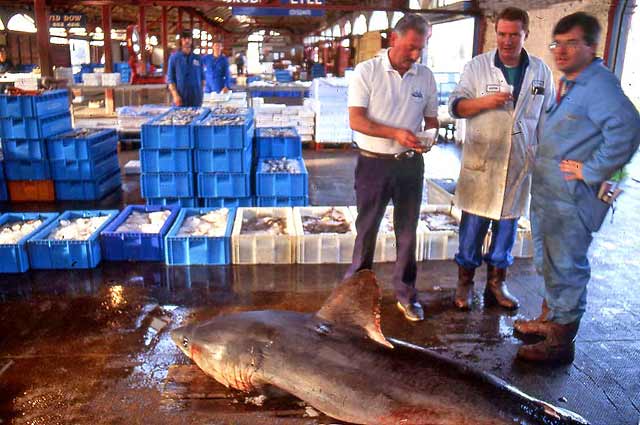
0, 90, 71, 202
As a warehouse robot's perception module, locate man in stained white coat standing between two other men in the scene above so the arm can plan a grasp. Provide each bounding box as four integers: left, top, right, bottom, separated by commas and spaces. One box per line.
449, 7, 554, 310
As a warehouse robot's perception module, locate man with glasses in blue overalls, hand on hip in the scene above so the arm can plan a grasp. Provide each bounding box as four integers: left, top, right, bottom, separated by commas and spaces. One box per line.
514, 12, 640, 363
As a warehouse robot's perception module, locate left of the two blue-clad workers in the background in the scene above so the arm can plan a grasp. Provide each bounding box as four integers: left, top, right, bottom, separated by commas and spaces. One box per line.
167, 30, 204, 106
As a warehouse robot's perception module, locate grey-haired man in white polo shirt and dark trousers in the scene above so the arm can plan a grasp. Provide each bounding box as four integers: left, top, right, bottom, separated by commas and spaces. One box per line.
347, 14, 438, 321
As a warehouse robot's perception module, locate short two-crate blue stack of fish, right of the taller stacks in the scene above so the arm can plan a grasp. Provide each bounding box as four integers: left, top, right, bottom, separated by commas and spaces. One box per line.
255, 127, 309, 207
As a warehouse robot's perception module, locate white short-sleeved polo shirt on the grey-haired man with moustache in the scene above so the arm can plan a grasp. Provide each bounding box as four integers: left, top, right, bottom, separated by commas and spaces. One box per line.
348, 50, 438, 154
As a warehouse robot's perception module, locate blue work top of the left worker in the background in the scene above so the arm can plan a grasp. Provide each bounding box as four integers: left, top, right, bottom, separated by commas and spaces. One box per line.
167, 50, 204, 106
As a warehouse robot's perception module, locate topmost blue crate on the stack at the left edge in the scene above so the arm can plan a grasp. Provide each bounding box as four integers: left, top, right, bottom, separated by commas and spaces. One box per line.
0, 89, 69, 118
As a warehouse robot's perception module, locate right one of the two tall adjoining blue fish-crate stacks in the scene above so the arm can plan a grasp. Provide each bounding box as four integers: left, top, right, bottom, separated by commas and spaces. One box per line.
194, 108, 254, 207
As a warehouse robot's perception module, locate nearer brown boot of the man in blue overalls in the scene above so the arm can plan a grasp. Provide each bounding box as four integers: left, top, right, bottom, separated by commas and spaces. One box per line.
517, 321, 580, 364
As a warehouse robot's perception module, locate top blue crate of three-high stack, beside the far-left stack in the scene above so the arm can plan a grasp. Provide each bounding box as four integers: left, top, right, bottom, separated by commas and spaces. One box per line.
47, 128, 118, 160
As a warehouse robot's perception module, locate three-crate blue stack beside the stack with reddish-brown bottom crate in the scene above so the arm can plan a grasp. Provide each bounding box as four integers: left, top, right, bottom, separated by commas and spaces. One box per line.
47, 128, 121, 201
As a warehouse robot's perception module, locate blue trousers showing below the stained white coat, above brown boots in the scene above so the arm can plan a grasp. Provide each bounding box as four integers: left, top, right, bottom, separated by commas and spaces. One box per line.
455, 211, 518, 269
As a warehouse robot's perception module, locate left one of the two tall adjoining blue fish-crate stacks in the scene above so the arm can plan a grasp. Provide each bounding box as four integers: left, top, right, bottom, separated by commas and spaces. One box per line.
140, 108, 209, 208
